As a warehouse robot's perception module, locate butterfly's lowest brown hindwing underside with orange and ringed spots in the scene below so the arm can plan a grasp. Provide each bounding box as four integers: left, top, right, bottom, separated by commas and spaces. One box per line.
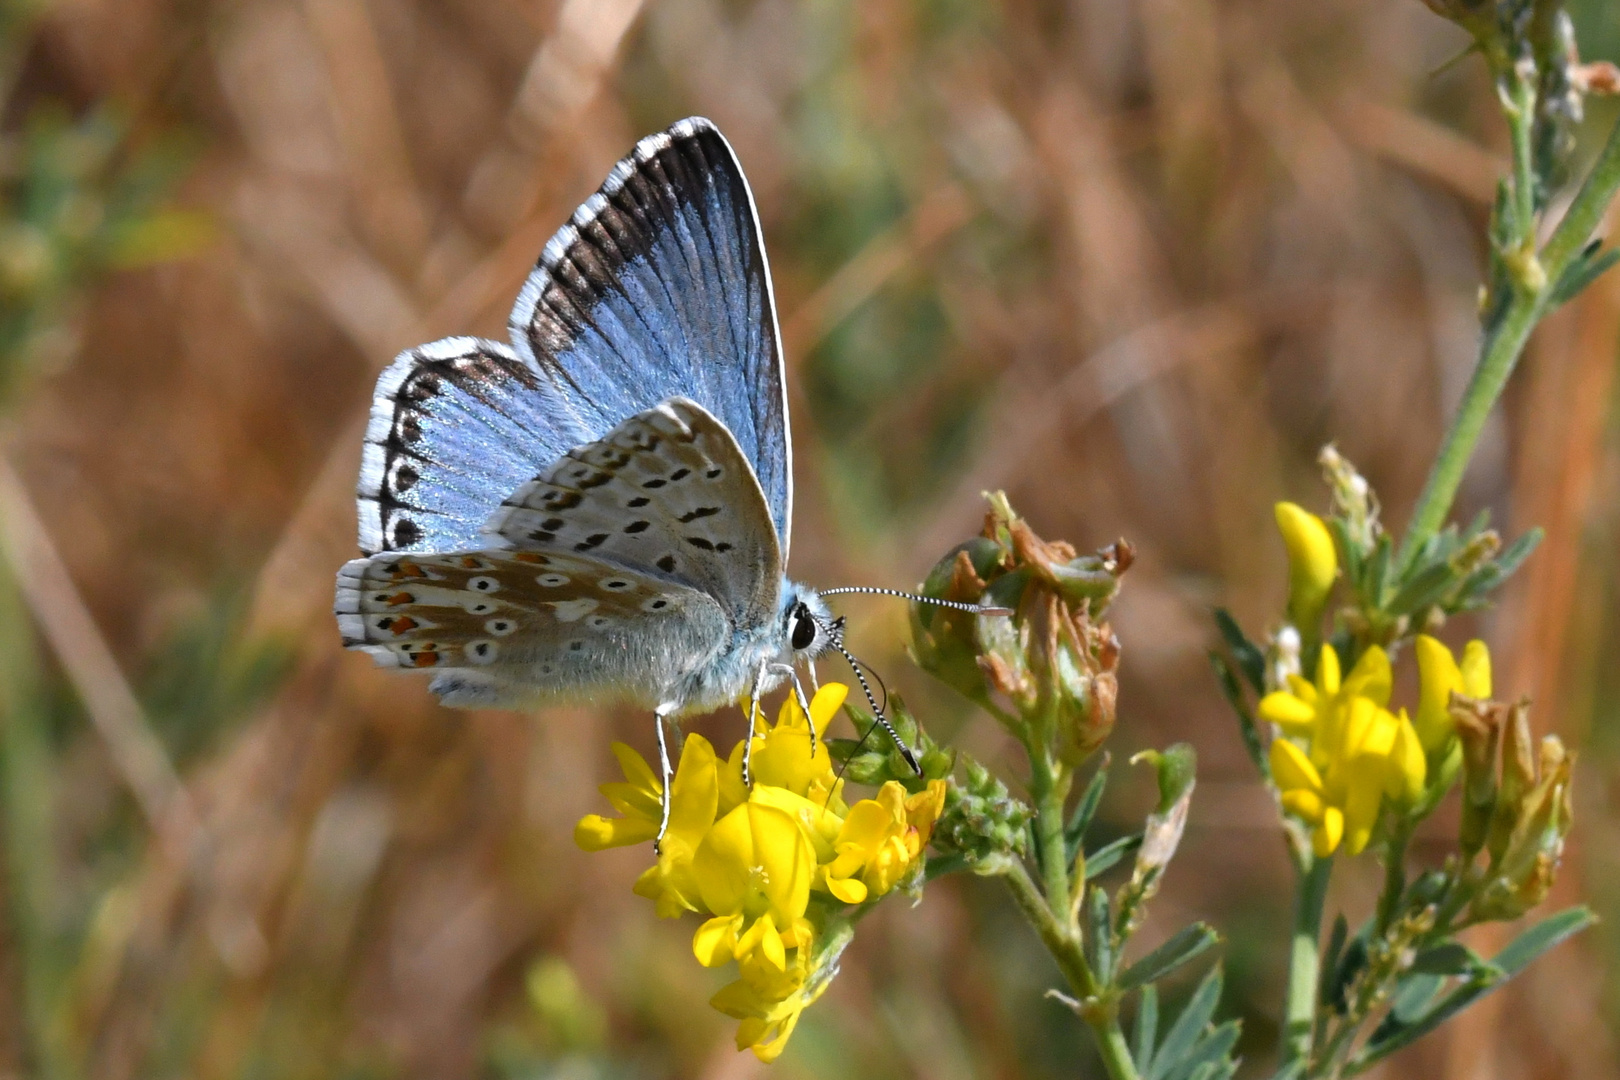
337, 551, 729, 708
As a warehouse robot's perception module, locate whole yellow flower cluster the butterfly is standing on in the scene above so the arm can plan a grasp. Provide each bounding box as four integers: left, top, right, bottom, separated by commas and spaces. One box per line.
573, 683, 944, 1062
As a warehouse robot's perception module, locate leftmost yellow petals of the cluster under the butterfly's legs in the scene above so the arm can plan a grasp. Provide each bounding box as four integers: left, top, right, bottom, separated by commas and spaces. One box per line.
573, 735, 719, 918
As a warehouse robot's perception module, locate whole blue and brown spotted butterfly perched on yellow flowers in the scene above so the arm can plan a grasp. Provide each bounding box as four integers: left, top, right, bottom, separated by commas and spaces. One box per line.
334, 117, 991, 841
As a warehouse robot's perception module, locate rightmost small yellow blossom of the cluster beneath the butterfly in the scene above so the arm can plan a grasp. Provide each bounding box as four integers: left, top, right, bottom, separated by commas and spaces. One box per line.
820, 780, 944, 904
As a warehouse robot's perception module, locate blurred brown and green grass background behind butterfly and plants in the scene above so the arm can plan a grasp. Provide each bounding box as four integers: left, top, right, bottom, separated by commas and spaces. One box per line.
0, 0, 1620, 1080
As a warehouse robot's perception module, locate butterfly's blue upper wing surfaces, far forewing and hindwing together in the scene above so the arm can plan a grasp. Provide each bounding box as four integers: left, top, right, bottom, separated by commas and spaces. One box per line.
358, 118, 792, 562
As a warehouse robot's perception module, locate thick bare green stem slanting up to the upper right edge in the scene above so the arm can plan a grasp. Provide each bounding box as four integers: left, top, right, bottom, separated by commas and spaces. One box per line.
1401, 110, 1620, 565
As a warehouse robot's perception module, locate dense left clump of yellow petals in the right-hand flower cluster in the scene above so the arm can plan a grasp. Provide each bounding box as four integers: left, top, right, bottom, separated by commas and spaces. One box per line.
1260, 646, 1427, 857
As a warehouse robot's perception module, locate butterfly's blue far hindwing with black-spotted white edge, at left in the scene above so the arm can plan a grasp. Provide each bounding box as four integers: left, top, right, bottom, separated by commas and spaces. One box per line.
358, 337, 593, 552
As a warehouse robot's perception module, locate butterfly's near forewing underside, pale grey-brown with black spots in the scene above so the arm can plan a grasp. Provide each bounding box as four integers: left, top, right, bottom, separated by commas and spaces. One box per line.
488, 398, 781, 625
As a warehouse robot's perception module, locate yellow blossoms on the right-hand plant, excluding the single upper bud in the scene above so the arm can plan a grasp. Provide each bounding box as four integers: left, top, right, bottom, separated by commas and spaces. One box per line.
1260, 635, 1490, 857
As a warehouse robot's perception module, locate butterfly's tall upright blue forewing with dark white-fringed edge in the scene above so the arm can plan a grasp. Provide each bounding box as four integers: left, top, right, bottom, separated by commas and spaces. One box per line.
510, 118, 792, 559
